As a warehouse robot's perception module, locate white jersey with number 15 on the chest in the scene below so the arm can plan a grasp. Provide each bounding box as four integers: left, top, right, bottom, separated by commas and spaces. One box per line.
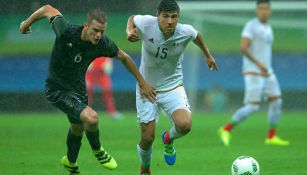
134, 15, 197, 91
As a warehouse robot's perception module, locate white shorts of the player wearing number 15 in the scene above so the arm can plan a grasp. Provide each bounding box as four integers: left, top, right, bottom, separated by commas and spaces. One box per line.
136, 86, 191, 123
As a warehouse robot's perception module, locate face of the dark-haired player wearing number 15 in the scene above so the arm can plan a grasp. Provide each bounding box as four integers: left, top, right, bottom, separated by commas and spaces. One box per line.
158, 12, 179, 34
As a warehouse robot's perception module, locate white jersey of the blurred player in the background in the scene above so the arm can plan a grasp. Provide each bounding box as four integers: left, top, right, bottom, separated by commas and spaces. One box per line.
242, 18, 274, 73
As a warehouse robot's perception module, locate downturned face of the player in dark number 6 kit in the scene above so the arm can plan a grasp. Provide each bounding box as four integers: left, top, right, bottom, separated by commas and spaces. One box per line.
84, 20, 107, 44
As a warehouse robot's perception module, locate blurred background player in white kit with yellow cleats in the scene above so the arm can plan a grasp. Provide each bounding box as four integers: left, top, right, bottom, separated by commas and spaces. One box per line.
219, 0, 289, 146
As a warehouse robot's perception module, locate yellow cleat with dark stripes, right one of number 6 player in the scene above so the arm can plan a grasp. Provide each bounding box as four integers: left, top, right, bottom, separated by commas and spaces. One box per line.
93, 147, 117, 170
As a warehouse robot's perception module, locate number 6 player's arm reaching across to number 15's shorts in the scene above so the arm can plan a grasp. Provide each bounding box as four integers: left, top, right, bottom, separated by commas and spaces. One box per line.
116, 49, 156, 102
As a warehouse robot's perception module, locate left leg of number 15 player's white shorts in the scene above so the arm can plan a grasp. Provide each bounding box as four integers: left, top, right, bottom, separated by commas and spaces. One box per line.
136, 88, 159, 124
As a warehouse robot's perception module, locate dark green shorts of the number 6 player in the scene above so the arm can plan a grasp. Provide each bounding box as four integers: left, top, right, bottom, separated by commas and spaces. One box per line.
45, 88, 88, 124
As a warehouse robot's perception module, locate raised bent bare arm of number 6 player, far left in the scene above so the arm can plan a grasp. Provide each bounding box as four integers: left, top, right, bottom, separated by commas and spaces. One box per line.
20, 5, 62, 34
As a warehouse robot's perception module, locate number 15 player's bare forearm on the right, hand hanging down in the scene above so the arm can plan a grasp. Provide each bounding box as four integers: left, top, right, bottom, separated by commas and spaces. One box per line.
193, 32, 217, 71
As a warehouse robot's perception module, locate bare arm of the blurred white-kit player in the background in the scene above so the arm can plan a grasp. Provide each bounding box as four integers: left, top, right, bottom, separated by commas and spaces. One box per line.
240, 37, 268, 74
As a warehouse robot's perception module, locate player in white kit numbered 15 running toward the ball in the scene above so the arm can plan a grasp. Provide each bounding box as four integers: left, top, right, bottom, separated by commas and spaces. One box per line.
126, 0, 217, 175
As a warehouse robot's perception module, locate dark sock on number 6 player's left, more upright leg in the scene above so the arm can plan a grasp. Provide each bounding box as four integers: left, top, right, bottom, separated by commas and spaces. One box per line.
66, 129, 82, 163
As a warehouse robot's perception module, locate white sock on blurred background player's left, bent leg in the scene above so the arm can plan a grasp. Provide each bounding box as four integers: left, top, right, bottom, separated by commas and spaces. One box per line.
232, 104, 260, 123
